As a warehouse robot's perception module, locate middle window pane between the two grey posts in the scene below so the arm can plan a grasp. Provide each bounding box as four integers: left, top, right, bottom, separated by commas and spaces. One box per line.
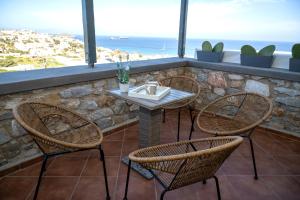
94, 0, 180, 63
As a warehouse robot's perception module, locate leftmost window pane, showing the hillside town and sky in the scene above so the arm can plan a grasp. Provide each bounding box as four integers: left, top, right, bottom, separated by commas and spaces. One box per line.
0, 0, 85, 72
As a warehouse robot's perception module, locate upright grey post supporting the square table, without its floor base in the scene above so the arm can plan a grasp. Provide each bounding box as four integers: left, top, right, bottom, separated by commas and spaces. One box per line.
139, 107, 161, 148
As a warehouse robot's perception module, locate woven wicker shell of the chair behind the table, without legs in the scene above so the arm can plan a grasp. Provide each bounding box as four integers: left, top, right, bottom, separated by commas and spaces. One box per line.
159, 76, 200, 109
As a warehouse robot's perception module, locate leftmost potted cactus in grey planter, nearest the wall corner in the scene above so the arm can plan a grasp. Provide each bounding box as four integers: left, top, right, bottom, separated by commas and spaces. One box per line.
196, 41, 224, 62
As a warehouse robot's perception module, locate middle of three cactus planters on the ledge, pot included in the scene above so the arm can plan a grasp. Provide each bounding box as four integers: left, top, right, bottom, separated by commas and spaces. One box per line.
240, 45, 276, 68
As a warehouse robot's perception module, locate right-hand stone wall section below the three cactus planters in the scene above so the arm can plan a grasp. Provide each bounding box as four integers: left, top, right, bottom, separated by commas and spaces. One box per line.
186, 67, 300, 134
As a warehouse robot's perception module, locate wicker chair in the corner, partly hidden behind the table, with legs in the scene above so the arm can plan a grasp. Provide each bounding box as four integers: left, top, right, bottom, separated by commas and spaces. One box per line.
159, 76, 200, 141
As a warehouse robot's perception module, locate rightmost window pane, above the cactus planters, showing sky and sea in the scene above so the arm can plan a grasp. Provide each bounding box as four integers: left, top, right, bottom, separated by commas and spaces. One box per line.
186, 0, 300, 57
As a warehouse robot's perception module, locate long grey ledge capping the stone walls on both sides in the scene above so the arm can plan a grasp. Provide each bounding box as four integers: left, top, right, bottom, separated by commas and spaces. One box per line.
0, 57, 300, 95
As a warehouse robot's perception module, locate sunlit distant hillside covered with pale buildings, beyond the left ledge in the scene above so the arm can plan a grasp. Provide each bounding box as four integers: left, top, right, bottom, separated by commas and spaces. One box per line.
0, 30, 145, 72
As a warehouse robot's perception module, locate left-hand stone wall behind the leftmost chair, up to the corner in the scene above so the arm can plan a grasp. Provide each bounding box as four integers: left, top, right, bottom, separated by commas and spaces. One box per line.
0, 68, 184, 171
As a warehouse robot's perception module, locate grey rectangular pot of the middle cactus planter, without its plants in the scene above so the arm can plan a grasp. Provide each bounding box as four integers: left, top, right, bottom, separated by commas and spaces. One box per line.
241, 54, 274, 68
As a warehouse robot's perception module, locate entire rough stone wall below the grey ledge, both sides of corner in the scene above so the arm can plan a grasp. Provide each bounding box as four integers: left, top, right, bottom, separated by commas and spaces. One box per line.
0, 67, 300, 171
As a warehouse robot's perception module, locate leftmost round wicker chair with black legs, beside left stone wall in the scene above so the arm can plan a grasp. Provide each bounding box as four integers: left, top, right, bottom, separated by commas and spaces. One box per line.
13, 102, 110, 199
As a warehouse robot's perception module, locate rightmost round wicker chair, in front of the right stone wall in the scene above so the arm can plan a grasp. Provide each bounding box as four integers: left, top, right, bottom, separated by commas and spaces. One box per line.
190, 93, 273, 179
